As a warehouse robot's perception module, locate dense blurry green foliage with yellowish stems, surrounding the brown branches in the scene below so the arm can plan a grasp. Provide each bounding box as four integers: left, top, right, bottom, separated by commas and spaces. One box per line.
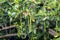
0, 0, 60, 40
